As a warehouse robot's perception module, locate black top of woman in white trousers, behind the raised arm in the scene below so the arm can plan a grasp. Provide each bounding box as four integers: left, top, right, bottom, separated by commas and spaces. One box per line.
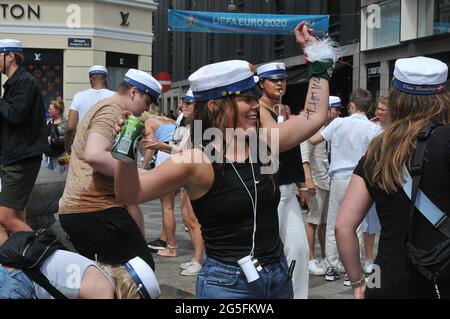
269, 110, 305, 185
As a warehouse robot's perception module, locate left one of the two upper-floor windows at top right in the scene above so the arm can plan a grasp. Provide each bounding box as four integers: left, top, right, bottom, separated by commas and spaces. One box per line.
363, 0, 400, 49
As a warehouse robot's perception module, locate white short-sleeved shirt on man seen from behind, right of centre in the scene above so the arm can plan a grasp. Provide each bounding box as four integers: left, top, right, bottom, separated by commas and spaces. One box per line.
320, 114, 381, 179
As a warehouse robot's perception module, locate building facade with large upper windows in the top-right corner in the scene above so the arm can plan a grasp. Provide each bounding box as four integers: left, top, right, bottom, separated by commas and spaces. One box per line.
360, 0, 450, 98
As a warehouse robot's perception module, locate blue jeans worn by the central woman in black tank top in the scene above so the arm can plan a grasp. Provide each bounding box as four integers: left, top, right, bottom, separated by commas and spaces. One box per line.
196, 256, 294, 299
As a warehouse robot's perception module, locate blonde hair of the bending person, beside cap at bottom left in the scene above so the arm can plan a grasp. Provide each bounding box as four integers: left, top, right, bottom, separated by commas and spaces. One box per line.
97, 262, 141, 299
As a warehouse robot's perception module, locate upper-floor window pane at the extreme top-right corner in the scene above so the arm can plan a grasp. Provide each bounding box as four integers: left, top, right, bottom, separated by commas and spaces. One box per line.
417, 0, 450, 37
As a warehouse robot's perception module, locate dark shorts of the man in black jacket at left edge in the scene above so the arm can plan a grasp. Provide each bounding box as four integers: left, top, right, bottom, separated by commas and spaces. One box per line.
0, 156, 42, 210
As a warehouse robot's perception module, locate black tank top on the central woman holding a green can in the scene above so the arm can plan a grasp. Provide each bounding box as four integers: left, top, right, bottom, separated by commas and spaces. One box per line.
191, 163, 283, 264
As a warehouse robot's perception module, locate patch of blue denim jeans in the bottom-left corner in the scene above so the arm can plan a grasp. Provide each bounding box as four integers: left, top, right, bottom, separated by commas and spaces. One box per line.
0, 265, 34, 299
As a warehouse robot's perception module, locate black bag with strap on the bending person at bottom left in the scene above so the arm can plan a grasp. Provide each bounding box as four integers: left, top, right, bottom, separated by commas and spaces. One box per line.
0, 229, 67, 299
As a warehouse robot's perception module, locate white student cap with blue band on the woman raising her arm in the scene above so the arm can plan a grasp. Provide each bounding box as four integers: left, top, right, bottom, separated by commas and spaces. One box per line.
189, 60, 258, 101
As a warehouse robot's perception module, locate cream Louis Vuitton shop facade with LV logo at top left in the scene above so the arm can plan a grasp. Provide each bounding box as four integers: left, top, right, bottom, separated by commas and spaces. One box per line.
0, 0, 158, 109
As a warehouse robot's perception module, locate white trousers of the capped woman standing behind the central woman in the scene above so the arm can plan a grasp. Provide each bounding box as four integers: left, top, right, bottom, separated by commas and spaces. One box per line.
278, 183, 309, 299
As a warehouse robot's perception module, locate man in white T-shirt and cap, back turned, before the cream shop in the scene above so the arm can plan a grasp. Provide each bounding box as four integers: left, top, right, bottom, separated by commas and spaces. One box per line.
65, 65, 115, 154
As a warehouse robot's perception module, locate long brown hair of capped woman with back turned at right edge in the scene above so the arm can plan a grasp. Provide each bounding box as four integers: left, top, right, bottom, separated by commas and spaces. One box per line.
364, 89, 450, 194
